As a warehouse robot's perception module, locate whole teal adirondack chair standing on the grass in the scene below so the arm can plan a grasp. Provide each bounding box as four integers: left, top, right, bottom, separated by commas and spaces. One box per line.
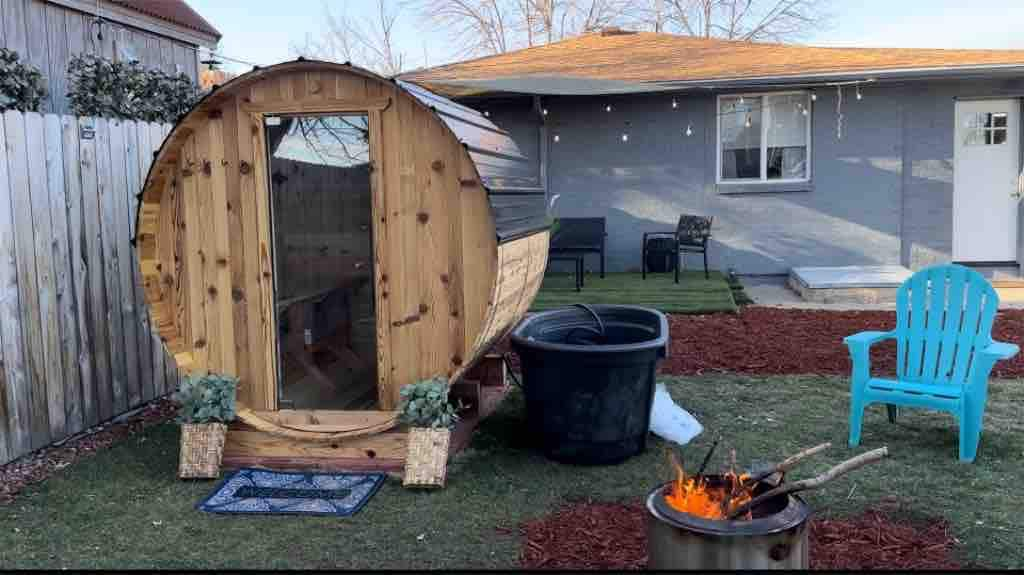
843, 265, 1019, 461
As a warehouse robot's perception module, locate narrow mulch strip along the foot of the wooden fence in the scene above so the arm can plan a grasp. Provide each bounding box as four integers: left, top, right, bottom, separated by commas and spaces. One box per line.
0, 398, 177, 504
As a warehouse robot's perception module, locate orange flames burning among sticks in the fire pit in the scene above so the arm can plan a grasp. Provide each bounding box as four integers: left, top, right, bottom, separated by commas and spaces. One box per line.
665, 454, 754, 520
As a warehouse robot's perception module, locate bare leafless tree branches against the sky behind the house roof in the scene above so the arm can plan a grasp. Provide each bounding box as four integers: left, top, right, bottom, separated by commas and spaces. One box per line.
292, 0, 833, 76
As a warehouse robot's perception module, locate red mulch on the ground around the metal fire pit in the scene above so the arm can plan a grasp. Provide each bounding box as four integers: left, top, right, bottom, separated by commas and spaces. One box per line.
519, 502, 961, 570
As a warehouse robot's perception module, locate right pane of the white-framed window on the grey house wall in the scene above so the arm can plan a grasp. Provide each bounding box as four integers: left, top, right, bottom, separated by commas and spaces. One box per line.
764, 94, 810, 180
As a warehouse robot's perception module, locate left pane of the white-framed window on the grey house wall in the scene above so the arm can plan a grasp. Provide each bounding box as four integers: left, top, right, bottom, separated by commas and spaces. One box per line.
719, 96, 761, 180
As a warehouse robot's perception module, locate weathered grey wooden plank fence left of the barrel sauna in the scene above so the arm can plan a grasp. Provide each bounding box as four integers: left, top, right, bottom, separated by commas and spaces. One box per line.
0, 112, 177, 463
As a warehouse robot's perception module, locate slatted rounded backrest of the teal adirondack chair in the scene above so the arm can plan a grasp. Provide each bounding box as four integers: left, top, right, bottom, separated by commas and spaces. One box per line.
896, 264, 999, 385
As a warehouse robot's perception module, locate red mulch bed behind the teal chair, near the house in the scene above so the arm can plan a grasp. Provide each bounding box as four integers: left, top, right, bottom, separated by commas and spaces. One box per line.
660, 306, 1024, 378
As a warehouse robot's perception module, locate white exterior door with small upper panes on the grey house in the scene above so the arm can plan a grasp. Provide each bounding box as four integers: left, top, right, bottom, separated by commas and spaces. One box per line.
953, 99, 1020, 262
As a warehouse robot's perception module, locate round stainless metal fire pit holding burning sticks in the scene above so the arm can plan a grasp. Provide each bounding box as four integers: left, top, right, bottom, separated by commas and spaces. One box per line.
647, 476, 811, 570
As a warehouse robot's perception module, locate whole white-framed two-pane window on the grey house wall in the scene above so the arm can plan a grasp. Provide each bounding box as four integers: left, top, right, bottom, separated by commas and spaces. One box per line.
718, 92, 811, 183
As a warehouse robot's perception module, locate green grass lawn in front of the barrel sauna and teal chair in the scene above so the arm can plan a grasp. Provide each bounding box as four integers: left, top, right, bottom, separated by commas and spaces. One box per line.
0, 377, 1024, 570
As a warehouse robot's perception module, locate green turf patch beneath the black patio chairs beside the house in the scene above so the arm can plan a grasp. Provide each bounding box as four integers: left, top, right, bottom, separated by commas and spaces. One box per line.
530, 271, 736, 313
